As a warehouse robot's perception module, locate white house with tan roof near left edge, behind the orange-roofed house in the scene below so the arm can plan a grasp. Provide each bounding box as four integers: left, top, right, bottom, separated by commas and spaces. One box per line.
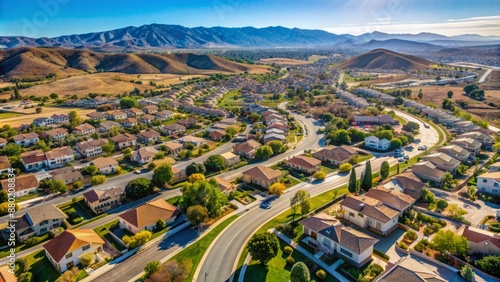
16, 204, 66, 243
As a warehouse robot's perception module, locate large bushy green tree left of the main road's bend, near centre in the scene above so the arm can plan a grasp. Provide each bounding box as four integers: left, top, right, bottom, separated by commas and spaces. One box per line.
181, 178, 227, 217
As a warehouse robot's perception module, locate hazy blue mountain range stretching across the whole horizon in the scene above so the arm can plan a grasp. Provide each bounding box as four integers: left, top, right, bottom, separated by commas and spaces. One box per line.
0, 24, 500, 51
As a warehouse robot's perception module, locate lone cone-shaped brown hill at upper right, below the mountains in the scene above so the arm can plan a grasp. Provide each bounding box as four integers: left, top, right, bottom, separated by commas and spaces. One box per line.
336, 49, 435, 70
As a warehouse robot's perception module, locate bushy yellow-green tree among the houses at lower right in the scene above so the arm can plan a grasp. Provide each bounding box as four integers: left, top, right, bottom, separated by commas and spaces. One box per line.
431, 230, 469, 256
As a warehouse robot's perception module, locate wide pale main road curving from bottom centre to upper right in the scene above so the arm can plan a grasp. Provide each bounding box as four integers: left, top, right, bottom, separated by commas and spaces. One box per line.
196, 108, 439, 282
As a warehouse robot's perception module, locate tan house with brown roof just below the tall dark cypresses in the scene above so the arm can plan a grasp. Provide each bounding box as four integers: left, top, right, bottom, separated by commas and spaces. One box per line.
340, 195, 399, 236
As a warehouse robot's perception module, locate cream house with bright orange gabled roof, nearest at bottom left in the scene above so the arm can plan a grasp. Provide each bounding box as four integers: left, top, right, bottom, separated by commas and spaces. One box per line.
43, 229, 104, 273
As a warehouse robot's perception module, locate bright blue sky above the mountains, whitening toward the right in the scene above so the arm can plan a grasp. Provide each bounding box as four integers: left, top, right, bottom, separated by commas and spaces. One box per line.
0, 0, 500, 37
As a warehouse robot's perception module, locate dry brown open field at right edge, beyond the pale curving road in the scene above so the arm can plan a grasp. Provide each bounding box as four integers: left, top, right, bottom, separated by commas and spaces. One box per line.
410, 85, 500, 125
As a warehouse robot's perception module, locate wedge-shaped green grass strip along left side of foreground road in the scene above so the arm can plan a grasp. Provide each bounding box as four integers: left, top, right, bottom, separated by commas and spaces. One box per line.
170, 215, 238, 281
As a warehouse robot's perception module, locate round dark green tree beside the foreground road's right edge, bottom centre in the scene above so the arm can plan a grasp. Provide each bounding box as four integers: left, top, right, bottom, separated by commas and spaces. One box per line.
247, 232, 280, 265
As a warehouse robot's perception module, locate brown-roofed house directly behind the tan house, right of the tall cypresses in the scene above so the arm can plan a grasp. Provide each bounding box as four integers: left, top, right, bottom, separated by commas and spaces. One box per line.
364, 186, 416, 216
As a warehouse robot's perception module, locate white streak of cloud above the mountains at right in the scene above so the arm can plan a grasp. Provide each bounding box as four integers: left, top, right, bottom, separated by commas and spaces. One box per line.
324, 16, 500, 36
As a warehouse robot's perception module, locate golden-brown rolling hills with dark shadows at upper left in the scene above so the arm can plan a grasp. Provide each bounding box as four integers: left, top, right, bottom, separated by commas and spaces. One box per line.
0, 47, 265, 80
